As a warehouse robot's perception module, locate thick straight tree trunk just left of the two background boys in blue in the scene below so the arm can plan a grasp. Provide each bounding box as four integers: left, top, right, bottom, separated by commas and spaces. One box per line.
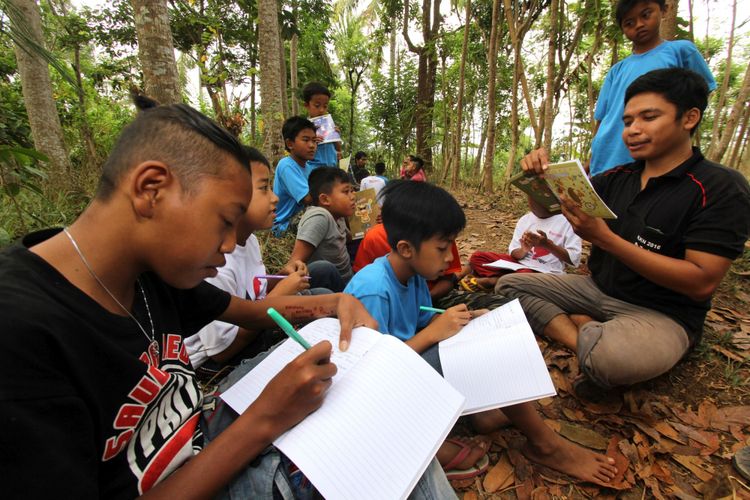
258, 0, 284, 165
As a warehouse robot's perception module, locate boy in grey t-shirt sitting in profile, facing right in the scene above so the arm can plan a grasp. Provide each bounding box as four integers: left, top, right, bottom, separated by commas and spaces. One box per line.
291, 167, 355, 292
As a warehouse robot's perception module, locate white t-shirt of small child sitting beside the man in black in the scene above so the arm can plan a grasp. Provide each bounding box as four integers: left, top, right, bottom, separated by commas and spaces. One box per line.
508, 212, 581, 274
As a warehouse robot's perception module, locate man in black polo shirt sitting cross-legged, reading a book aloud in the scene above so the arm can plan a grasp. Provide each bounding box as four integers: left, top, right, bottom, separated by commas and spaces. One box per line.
496, 68, 750, 389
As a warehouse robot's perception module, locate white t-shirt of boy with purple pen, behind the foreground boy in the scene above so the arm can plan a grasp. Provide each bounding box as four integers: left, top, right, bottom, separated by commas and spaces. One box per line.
185, 234, 268, 368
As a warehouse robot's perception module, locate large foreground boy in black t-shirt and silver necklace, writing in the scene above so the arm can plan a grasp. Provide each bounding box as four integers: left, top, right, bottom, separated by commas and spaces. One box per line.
0, 98, 456, 499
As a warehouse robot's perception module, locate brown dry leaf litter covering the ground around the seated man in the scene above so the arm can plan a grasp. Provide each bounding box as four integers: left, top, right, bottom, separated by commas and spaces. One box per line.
446, 190, 750, 500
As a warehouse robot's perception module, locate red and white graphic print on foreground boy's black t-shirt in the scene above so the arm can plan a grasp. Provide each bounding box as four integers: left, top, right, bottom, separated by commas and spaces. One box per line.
102, 335, 202, 493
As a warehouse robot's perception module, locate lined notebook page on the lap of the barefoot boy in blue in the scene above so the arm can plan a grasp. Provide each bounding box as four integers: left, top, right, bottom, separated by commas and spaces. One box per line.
439, 300, 556, 415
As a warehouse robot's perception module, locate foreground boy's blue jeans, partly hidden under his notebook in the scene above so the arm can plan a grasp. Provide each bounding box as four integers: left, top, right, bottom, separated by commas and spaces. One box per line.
201, 347, 457, 500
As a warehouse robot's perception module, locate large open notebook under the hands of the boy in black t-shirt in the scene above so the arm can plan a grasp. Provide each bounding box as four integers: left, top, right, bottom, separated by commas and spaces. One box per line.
222, 318, 464, 499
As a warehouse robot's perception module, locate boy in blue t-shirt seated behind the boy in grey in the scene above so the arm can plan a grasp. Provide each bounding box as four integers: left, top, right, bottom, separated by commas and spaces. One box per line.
273, 116, 318, 236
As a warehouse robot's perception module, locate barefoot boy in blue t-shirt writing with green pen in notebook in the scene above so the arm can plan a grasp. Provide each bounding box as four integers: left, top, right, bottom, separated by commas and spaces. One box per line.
345, 181, 616, 482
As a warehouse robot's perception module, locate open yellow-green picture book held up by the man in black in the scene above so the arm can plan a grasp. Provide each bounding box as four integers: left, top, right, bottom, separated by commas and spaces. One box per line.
511, 160, 617, 219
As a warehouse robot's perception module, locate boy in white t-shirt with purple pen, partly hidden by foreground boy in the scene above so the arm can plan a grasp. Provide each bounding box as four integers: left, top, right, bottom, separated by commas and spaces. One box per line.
185, 146, 338, 374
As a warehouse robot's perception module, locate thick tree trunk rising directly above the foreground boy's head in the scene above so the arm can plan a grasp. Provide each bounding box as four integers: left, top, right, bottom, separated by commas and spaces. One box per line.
131, 0, 182, 104
